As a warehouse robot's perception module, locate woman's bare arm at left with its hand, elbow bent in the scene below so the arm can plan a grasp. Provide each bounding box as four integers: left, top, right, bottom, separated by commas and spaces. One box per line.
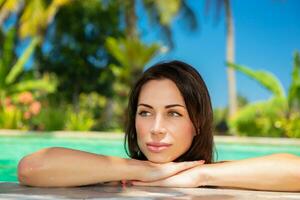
18, 147, 199, 187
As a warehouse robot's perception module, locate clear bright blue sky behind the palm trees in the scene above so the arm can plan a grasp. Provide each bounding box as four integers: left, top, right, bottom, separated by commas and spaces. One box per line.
139, 0, 300, 107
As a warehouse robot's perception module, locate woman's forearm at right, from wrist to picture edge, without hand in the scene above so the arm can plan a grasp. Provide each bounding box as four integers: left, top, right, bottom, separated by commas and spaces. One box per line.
202, 154, 300, 191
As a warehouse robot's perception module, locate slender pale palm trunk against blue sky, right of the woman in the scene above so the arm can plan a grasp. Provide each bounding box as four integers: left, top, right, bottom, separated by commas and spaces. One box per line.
224, 0, 237, 118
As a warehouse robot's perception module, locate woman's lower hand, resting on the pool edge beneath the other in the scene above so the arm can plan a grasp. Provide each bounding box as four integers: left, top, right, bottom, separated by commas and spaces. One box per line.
131, 166, 205, 188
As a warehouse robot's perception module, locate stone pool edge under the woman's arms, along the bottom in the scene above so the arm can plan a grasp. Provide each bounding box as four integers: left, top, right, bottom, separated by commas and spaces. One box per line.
0, 182, 300, 200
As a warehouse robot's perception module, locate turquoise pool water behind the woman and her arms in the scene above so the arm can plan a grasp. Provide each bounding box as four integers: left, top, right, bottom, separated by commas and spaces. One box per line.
0, 135, 300, 181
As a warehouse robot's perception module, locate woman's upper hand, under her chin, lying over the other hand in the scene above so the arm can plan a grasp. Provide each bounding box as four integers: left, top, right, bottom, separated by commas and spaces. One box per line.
137, 160, 205, 183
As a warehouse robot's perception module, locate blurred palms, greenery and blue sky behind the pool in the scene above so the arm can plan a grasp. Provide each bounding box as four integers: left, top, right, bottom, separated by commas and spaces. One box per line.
0, 0, 300, 138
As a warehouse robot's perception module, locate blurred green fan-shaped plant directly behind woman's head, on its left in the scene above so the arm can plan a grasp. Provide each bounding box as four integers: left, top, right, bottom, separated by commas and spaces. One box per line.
106, 37, 159, 129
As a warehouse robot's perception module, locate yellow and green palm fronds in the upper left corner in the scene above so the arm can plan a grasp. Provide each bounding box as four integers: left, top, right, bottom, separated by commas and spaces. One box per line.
0, 0, 71, 99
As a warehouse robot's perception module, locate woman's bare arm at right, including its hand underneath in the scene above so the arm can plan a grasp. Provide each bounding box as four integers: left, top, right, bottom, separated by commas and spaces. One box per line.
133, 154, 300, 191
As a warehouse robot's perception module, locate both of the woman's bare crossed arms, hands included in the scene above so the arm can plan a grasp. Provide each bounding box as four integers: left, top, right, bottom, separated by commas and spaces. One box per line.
18, 147, 300, 191
